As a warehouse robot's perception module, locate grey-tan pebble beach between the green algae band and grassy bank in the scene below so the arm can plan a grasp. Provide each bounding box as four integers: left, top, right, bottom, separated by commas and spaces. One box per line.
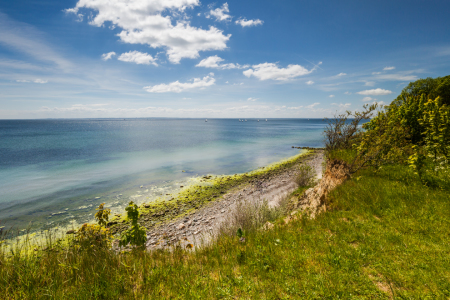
128, 150, 324, 250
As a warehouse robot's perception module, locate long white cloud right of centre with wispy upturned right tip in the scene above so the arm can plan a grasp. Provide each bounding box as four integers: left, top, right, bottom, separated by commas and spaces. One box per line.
243, 63, 321, 81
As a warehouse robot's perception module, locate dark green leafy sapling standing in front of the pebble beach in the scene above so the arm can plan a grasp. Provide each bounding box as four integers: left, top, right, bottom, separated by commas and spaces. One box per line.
119, 201, 147, 247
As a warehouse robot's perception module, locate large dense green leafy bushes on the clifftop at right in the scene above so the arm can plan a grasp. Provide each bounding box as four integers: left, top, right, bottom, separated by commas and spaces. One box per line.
352, 76, 450, 176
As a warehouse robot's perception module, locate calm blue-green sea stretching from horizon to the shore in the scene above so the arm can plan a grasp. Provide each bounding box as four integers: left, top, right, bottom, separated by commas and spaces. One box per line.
0, 119, 326, 229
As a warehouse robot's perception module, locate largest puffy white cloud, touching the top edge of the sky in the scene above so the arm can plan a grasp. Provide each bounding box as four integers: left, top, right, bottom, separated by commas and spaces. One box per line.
66, 0, 231, 63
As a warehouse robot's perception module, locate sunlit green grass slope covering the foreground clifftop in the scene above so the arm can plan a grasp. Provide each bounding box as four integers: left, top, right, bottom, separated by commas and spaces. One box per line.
0, 162, 450, 299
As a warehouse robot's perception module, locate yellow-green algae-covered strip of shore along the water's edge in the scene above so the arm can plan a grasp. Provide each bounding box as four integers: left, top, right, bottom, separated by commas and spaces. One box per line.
0, 148, 323, 250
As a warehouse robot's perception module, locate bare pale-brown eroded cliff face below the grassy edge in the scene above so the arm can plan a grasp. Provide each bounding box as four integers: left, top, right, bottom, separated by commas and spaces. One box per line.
292, 160, 350, 218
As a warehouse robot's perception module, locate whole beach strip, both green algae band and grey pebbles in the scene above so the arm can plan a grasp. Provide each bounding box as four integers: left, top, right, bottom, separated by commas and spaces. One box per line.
108, 150, 323, 249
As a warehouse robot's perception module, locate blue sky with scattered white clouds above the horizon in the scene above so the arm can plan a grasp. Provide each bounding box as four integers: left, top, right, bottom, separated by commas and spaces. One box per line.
0, 0, 450, 119
